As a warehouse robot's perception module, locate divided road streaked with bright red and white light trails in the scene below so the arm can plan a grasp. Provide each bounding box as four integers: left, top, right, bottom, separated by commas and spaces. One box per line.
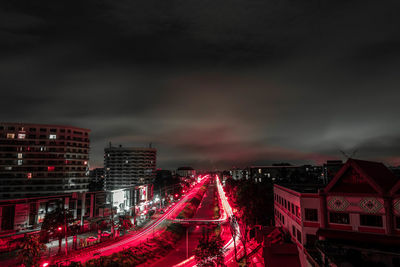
1, 176, 242, 267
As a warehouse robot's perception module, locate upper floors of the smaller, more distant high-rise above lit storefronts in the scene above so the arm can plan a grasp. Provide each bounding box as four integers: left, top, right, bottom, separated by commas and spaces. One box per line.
104, 145, 157, 190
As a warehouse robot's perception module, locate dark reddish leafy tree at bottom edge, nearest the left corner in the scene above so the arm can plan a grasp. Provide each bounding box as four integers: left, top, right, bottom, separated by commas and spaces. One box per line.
18, 235, 46, 267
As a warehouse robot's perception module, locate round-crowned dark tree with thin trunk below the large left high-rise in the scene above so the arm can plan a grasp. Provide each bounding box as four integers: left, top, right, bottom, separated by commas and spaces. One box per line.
41, 208, 74, 253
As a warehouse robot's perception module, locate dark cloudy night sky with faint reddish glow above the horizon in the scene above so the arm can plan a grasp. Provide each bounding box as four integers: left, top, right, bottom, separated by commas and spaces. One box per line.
0, 0, 400, 168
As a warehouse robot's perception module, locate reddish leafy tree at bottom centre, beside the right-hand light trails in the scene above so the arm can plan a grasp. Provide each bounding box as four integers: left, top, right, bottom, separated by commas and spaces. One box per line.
194, 231, 225, 267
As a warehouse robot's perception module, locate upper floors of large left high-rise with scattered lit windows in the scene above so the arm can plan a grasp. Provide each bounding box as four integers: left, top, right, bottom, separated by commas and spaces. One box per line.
0, 123, 90, 199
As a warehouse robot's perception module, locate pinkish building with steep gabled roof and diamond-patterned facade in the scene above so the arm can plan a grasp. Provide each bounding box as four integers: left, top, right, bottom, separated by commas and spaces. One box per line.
274, 159, 400, 266
